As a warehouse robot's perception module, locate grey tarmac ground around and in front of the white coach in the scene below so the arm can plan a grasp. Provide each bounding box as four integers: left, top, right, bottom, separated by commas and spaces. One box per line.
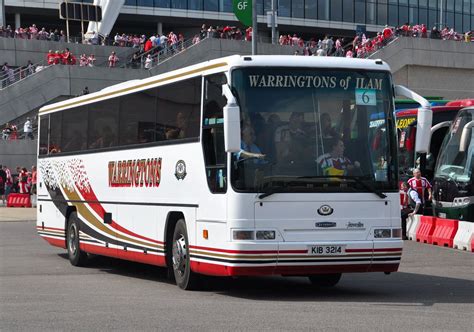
0, 214, 474, 331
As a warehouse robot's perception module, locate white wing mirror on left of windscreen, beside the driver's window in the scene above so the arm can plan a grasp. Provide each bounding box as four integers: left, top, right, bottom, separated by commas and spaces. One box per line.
222, 84, 240, 152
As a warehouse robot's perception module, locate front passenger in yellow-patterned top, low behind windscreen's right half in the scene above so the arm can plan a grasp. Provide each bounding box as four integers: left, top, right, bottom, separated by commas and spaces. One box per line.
317, 138, 360, 176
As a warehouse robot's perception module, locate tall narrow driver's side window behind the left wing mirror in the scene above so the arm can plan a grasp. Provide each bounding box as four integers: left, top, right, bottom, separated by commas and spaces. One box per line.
202, 74, 227, 193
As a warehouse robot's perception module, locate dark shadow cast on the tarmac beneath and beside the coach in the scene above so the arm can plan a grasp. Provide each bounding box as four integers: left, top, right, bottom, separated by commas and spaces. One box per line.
59, 254, 474, 307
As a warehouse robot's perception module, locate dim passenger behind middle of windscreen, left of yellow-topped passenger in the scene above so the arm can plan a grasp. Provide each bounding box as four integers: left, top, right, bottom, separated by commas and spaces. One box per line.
274, 112, 307, 161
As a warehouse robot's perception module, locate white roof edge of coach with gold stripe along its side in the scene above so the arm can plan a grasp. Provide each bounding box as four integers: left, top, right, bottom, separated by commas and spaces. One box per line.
39, 55, 390, 114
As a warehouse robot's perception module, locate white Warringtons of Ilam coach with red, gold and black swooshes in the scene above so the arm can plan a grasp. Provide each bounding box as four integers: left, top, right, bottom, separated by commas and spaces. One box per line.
37, 56, 431, 289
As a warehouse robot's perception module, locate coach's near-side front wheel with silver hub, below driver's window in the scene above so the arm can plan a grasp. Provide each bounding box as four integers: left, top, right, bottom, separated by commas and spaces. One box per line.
172, 219, 198, 290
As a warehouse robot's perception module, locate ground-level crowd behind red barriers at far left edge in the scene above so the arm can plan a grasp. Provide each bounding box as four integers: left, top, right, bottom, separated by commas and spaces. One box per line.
0, 165, 37, 205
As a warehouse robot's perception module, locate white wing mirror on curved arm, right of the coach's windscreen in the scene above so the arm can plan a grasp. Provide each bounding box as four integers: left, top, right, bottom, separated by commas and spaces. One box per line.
395, 85, 433, 153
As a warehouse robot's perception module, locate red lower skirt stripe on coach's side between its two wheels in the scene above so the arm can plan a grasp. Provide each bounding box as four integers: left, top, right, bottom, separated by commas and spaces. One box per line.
80, 242, 166, 266
